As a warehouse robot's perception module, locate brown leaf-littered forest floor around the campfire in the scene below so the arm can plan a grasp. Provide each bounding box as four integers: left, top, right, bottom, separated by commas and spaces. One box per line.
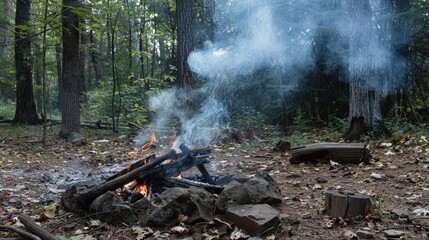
0, 123, 429, 240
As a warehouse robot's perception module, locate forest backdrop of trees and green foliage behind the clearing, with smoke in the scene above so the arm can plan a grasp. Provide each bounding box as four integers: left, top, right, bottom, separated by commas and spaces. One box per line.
0, 0, 429, 142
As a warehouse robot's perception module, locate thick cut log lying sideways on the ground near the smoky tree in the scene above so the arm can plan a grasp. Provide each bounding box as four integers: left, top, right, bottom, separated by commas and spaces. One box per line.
289, 143, 370, 164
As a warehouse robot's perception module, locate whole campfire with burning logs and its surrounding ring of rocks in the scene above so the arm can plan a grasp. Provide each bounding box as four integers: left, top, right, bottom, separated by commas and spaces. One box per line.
61, 130, 282, 233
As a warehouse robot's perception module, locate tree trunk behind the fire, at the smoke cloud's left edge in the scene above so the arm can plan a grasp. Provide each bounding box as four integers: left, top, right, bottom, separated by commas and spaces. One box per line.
176, 0, 194, 116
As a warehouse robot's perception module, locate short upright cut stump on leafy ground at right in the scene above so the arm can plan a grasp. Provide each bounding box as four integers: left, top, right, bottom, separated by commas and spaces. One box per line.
325, 191, 371, 218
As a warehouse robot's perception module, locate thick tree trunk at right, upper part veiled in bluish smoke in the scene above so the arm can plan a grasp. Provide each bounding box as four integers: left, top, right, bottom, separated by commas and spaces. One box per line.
344, 0, 387, 139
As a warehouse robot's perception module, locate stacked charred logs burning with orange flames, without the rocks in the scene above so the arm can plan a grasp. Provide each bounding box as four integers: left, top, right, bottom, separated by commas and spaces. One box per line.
63, 142, 223, 211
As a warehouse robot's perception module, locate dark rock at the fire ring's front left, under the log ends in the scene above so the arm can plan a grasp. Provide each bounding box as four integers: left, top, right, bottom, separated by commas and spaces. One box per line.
90, 192, 138, 226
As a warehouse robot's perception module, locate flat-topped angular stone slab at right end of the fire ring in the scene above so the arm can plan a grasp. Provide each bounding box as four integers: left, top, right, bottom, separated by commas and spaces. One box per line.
226, 204, 280, 235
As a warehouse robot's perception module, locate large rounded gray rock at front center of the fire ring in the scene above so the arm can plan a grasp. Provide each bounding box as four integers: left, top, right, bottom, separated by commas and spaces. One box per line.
142, 187, 214, 226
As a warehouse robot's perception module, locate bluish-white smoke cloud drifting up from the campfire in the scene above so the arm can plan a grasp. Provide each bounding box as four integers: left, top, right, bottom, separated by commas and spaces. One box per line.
142, 0, 406, 146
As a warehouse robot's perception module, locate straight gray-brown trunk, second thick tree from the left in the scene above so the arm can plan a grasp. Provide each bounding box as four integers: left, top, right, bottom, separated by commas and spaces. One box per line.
60, 0, 80, 138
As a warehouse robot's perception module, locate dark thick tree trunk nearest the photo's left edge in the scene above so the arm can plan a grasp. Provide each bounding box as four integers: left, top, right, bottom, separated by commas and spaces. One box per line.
14, 0, 40, 124
